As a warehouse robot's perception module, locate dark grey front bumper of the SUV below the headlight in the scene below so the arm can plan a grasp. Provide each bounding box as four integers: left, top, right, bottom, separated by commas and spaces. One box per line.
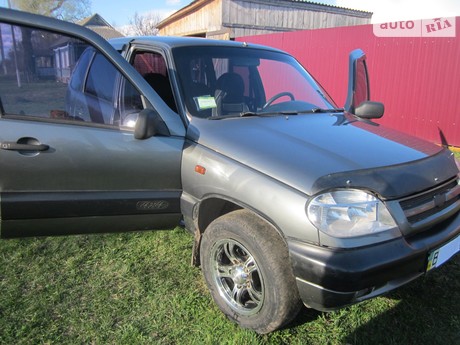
288, 213, 460, 311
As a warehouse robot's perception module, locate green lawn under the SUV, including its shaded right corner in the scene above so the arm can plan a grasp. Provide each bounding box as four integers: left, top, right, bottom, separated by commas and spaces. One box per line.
0, 228, 460, 345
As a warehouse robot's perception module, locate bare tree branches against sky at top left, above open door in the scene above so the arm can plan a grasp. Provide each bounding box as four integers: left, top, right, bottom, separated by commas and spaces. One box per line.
9, 0, 91, 22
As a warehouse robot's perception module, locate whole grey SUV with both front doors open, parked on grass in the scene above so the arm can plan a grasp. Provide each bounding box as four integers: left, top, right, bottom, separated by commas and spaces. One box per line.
0, 9, 460, 333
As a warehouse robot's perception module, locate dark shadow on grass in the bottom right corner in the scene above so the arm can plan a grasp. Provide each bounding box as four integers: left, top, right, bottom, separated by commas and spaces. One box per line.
343, 257, 460, 345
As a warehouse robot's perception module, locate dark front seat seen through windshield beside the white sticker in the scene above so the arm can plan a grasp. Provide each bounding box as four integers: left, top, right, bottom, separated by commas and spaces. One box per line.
213, 72, 249, 116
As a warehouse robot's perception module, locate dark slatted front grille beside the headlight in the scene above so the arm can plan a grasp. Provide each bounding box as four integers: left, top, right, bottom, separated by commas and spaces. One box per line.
400, 179, 460, 225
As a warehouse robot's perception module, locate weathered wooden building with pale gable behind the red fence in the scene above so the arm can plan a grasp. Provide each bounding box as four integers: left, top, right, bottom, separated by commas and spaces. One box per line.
157, 0, 372, 39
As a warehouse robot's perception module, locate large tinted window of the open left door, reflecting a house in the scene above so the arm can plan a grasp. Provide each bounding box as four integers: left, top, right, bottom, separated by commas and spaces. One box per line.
0, 24, 143, 127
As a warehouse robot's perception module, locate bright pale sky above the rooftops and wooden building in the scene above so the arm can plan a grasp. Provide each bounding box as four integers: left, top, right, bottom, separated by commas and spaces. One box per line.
86, 0, 460, 27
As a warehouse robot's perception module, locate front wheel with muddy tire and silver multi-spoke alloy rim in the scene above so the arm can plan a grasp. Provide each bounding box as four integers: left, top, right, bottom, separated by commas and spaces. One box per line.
200, 210, 301, 333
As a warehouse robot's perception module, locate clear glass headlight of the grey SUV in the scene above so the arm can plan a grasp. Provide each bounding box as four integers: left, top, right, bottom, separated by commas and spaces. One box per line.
307, 189, 397, 238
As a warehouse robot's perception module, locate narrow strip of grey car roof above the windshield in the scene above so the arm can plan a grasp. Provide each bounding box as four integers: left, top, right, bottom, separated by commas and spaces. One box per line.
109, 36, 284, 53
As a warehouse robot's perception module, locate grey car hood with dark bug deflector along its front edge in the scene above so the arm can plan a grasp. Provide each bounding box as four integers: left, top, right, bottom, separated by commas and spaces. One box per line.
188, 114, 457, 198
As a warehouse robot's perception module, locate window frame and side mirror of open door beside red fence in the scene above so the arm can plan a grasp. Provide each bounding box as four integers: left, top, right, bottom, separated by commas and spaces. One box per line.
344, 49, 385, 119
